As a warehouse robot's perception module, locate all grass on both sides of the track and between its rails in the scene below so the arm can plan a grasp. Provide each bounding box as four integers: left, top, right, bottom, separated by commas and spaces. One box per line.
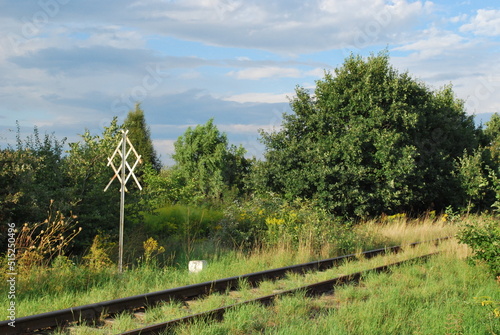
0, 214, 500, 334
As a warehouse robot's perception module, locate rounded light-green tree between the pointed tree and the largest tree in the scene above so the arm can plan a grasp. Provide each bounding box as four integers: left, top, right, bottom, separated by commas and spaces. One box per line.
172, 119, 249, 200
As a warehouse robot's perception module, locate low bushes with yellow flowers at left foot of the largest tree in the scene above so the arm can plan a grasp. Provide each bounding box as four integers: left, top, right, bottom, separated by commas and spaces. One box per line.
212, 194, 372, 253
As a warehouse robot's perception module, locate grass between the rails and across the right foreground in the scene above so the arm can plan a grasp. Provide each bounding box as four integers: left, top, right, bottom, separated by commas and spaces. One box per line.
48, 241, 500, 334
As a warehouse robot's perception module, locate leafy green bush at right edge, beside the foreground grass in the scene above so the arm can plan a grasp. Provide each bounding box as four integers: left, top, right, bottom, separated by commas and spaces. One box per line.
457, 216, 500, 276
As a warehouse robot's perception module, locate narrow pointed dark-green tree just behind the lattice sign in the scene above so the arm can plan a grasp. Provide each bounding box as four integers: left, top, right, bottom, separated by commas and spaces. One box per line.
123, 103, 161, 172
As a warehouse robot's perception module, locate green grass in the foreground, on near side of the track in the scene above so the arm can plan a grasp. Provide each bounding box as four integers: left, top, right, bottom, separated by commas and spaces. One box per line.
170, 254, 500, 335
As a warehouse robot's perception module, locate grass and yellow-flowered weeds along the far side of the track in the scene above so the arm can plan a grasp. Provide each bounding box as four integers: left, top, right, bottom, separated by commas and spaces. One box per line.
0, 219, 468, 317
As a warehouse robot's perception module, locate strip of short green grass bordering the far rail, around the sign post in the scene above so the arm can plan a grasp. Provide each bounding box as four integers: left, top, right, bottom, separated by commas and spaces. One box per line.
0, 243, 340, 317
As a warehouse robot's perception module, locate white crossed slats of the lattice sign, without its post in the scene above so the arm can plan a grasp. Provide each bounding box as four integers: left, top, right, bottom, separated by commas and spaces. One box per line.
104, 130, 142, 192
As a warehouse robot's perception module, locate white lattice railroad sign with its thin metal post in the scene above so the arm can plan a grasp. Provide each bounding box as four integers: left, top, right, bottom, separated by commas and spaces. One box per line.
104, 130, 142, 272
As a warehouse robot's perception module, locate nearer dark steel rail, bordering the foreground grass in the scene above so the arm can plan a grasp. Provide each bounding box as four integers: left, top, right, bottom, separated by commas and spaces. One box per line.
120, 252, 438, 335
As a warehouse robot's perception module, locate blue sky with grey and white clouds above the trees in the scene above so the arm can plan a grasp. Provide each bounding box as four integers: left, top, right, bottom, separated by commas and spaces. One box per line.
0, 0, 500, 164
